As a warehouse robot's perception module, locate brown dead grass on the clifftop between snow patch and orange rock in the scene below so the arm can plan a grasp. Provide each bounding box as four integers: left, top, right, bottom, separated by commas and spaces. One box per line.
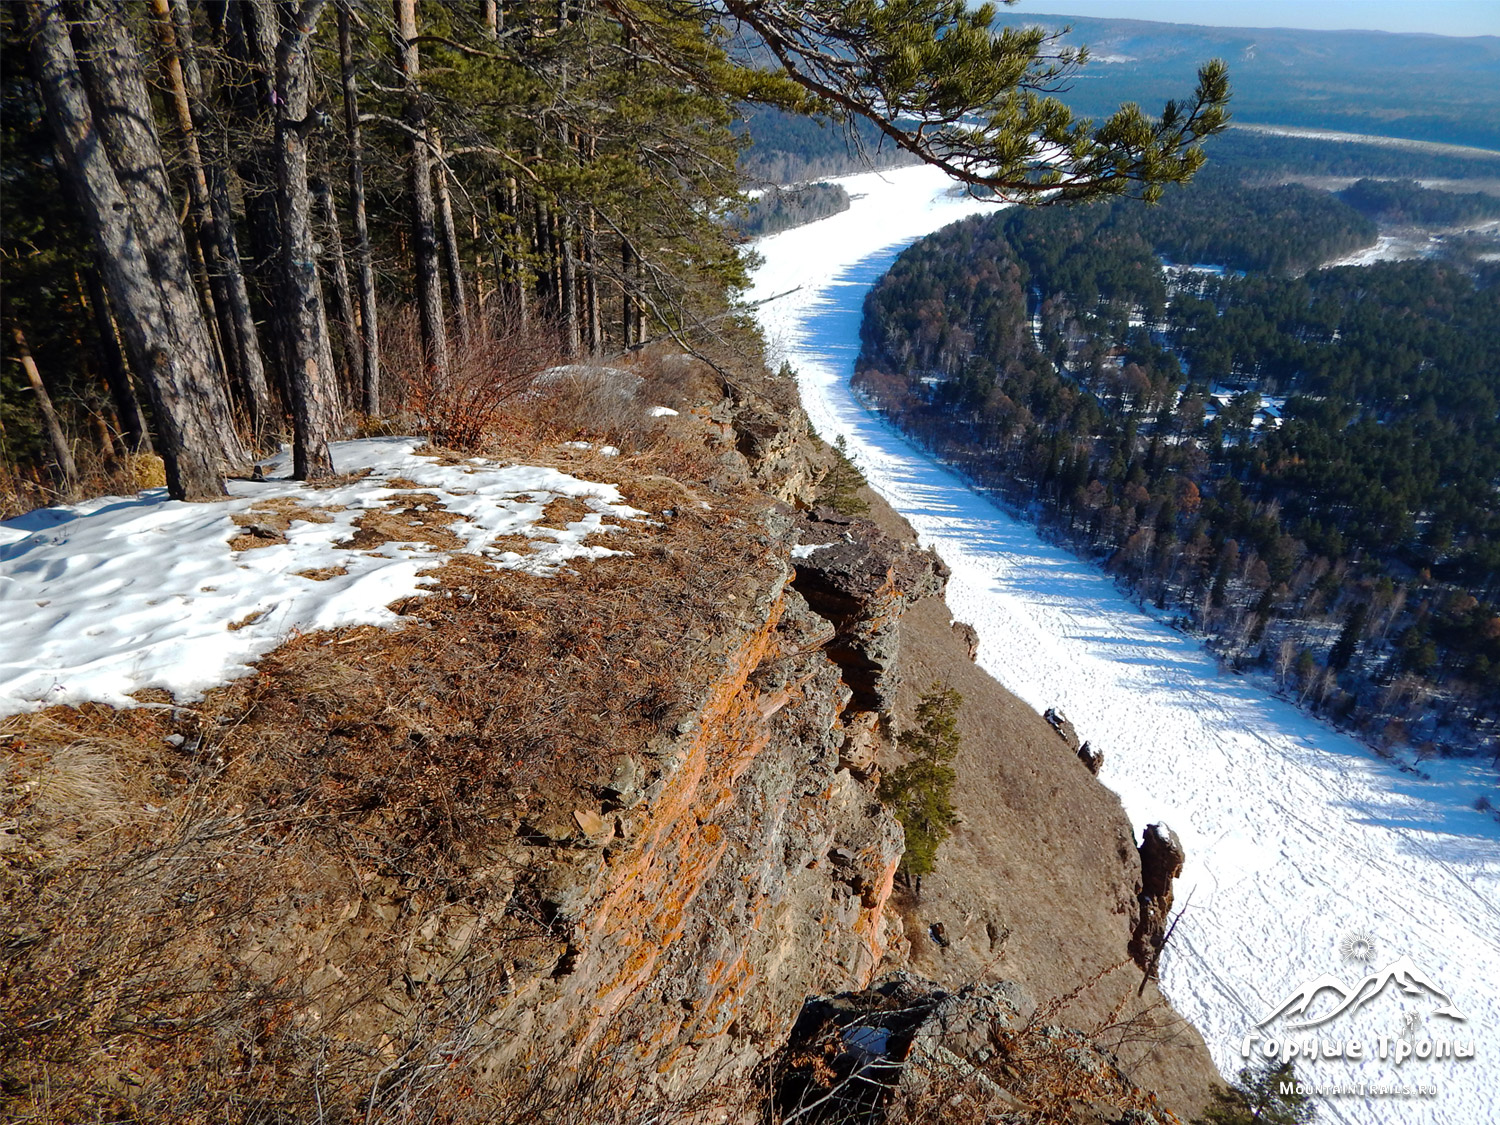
0, 459, 765, 1125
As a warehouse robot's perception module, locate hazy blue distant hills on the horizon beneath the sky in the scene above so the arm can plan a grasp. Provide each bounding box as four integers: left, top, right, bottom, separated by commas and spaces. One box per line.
996, 12, 1500, 149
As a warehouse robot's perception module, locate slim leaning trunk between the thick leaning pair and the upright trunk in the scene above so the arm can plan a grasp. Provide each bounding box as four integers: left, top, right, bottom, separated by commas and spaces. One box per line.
161, 0, 276, 446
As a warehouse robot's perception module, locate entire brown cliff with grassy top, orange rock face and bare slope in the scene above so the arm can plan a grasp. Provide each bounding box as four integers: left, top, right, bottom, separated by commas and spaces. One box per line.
0, 360, 1214, 1122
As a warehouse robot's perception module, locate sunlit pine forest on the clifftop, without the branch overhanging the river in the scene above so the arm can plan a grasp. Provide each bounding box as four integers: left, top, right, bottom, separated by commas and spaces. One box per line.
0, 0, 762, 510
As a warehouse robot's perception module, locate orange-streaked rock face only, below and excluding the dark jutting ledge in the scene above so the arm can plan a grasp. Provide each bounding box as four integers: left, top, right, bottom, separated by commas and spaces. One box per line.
498, 552, 902, 1089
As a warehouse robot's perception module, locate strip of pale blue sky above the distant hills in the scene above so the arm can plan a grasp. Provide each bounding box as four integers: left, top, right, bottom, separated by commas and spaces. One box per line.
1010, 0, 1500, 35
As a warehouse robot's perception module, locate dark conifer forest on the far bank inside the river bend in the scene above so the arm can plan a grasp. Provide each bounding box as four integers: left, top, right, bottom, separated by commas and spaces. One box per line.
857, 185, 1500, 753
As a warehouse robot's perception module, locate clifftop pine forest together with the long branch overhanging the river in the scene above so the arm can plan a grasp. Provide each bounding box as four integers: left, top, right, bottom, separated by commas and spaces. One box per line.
0, 0, 1229, 513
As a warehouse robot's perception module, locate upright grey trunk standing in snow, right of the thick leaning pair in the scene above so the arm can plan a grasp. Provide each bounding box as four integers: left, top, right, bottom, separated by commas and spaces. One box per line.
249, 0, 342, 480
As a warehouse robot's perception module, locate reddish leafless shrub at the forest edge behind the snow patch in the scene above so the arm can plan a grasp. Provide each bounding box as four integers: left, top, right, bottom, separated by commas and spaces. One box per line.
381, 309, 560, 450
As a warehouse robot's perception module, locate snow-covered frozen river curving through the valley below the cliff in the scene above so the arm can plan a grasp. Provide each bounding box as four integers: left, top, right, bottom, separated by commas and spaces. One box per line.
750, 168, 1500, 1125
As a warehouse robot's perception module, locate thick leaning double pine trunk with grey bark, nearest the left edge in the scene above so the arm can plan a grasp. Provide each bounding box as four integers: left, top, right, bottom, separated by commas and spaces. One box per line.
27, 0, 237, 500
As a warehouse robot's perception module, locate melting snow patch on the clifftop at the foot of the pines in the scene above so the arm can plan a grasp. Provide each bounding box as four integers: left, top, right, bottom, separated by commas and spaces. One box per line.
0, 438, 644, 716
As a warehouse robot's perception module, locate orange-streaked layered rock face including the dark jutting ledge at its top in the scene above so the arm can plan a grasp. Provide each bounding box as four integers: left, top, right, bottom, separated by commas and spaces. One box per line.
483, 480, 945, 1091
